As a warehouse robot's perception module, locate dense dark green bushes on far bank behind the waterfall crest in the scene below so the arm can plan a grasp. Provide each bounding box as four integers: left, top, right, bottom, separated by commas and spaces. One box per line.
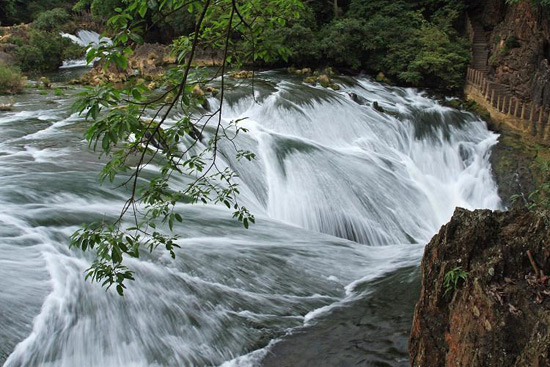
278, 0, 469, 89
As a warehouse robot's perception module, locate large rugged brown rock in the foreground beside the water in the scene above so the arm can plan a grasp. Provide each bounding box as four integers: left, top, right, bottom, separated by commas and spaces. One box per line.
409, 209, 550, 367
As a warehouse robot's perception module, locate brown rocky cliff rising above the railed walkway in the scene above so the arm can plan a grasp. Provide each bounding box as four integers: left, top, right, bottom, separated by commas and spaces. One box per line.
469, 0, 550, 105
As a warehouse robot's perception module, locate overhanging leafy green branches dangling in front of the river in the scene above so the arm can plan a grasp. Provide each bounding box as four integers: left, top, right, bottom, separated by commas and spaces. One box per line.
71, 0, 303, 294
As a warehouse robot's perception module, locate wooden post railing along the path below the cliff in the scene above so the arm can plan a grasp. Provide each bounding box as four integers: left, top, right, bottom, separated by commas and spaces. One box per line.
466, 68, 550, 143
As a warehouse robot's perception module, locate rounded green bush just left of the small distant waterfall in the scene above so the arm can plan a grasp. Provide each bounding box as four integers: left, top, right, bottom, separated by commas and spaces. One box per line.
15, 30, 84, 73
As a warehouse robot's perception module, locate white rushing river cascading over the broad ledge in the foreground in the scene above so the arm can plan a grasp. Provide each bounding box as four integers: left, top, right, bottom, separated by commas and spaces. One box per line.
0, 72, 501, 367
